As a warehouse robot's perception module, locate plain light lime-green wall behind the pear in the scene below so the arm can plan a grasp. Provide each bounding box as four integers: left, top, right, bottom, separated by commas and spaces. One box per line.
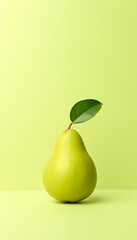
0, 0, 137, 190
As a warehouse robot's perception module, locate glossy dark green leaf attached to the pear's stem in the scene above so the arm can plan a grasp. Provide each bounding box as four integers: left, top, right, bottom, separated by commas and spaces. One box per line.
70, 99, 102, 124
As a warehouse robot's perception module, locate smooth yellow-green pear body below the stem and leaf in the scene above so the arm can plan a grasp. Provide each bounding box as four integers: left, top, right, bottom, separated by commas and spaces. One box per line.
43, 129, 97, 202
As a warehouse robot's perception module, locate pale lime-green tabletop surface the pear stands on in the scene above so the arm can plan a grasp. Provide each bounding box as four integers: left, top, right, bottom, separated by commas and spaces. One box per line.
0, 190, 137, 240
